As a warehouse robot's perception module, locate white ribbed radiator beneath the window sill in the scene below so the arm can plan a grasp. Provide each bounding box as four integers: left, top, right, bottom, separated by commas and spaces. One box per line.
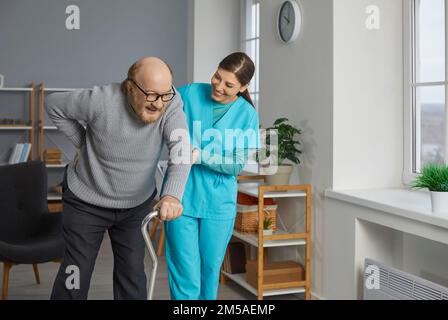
363, 258, 448, 300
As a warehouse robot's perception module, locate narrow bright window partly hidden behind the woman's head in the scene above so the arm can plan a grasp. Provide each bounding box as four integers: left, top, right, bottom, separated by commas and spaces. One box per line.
241, 0, 260, 111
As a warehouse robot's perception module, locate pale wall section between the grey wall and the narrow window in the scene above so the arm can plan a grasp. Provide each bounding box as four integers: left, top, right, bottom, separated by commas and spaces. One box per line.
187, 0, 240, 82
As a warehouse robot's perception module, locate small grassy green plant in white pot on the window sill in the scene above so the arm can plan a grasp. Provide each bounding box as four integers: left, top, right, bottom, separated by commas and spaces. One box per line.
411, 164, 448, 213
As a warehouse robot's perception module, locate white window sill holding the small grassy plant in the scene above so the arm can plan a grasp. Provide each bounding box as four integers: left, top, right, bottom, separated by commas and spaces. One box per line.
325, 188, 448, 229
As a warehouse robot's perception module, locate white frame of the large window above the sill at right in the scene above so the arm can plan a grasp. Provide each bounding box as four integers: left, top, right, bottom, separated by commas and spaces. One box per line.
403, 0, 448, 185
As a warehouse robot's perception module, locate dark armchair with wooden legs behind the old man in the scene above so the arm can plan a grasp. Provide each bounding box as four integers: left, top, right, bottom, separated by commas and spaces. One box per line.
0, 161, 64, 299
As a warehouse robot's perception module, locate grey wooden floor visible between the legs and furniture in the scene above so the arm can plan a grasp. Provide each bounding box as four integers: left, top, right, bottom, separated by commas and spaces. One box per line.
0, 231, 303, 300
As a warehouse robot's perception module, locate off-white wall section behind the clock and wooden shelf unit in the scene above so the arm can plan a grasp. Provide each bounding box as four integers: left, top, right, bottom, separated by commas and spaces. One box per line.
259, 0, 333, 300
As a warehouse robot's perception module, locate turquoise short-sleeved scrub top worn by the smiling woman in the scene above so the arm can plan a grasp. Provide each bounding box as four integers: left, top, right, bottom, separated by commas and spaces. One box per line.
178, 83, 260, 220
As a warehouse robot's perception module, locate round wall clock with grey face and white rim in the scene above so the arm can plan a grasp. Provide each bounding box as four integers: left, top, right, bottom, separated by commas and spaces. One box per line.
278, 1, 301, 42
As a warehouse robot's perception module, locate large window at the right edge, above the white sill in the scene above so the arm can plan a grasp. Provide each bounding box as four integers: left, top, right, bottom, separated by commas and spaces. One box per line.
404, 0, 448, 181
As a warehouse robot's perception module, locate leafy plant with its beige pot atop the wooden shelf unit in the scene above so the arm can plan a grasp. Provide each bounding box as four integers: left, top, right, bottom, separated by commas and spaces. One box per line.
257, 118, 302, 185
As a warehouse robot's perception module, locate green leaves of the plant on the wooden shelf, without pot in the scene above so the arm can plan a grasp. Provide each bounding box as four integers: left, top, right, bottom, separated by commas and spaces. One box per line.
257, 118, 302, 165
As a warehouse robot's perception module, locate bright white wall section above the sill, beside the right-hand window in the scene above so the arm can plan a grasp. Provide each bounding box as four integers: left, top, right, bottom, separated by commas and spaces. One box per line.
333, 0, 403, 189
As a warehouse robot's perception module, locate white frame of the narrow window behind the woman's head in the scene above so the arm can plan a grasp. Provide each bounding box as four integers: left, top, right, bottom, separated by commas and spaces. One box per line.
241, 0, 261, 112
